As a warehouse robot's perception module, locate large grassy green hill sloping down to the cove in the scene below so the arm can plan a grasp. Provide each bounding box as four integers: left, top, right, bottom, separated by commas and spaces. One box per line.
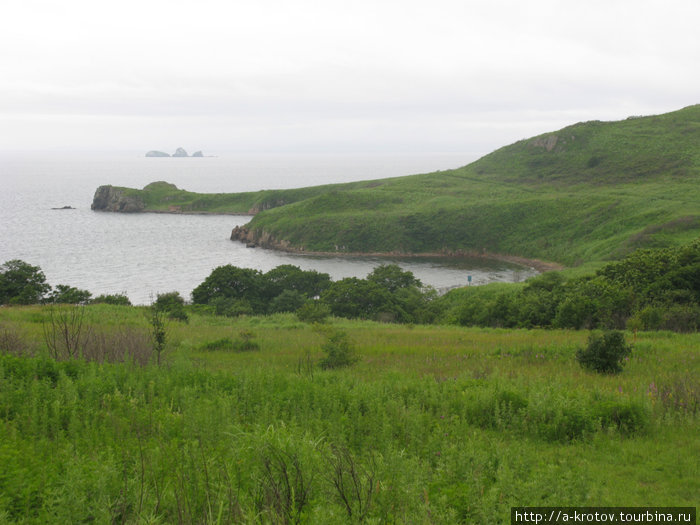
93, 105, 700, 265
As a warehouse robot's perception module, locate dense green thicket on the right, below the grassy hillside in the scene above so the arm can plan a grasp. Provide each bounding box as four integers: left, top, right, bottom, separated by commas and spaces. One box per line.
443, 240, 700, 332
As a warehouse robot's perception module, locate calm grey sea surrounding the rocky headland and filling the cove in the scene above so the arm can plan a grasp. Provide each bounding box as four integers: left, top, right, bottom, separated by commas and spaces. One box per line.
0, 152, 536, 304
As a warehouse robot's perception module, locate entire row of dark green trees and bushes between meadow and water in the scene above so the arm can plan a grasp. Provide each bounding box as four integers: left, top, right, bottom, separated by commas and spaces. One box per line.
0, 240, 700, 332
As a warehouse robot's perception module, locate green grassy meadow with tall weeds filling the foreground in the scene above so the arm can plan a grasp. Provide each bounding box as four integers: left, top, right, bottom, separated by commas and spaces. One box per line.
0, 305, 700, 524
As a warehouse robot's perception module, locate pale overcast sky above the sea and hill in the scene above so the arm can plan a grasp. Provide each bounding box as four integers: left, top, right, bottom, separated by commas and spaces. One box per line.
0, 0, 700, 153
